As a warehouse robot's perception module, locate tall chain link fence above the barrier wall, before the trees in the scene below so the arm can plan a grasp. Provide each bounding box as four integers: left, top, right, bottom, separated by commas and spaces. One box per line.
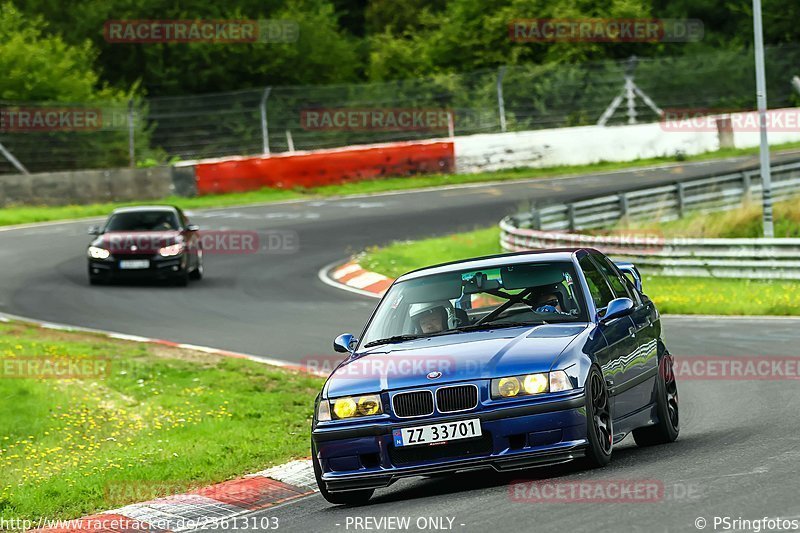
0, 45, 800, 173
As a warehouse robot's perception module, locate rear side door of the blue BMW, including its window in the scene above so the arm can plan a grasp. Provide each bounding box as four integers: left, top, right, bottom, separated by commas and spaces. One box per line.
591, 253, 659, 414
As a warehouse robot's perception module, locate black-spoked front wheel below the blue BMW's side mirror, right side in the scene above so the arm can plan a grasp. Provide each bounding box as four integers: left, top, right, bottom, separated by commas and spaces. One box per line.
583, 367, 614, 468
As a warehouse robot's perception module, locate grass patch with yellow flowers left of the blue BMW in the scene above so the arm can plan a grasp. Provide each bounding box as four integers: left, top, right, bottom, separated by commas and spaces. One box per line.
0, 322, 322, 519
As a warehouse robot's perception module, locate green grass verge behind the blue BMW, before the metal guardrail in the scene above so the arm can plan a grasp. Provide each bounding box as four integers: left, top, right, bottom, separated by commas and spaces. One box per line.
358, 227, 800, 316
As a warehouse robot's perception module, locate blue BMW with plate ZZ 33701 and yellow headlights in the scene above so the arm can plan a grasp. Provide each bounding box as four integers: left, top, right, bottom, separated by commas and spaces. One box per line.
311, 249, 679, 505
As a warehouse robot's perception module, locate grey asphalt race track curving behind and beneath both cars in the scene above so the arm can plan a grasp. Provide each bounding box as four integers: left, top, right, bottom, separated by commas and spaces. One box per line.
0, 154, 800, 532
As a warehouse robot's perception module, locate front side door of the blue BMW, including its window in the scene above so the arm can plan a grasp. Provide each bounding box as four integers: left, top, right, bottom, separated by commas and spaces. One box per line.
578, 254, 637, 424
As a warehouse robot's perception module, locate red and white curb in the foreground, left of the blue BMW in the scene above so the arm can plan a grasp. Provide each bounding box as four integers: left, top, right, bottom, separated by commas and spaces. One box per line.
38, 460, 317, 533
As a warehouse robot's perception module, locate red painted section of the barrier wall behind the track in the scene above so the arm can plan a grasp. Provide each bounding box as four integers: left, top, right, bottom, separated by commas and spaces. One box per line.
195, 141, 455, 195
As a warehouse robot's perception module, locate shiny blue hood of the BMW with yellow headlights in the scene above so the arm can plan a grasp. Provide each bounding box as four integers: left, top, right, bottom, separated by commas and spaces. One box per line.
326, 323, 589, 398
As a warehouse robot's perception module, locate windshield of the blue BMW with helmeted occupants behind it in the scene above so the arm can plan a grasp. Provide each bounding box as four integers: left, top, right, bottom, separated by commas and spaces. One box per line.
361, 262, 587, 347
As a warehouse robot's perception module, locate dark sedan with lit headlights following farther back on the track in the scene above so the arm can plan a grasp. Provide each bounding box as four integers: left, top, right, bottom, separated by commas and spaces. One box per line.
86, 206, 203, 286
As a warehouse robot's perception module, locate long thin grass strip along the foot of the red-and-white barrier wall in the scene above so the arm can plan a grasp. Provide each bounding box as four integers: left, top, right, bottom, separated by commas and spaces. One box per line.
0, 143, 800, 226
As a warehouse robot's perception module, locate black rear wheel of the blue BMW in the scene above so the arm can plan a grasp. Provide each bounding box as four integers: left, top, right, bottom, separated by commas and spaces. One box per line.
633, 352, 681, 446
